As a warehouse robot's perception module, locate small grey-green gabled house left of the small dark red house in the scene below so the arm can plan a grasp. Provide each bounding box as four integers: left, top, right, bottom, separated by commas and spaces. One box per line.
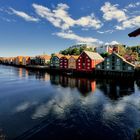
50, 54, 63, 68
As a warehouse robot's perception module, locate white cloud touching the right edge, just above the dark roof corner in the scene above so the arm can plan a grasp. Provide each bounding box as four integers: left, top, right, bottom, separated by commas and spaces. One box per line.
116, 16, 140, 30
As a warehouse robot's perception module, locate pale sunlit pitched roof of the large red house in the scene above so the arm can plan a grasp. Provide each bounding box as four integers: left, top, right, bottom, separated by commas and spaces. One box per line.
84, 51, 104, 60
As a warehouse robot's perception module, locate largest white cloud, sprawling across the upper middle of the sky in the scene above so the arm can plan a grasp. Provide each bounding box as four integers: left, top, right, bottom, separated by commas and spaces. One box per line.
32, 3, 102, 30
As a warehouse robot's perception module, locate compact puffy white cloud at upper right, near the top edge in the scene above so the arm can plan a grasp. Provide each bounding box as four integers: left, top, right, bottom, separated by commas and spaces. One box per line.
100, 2, 127, 22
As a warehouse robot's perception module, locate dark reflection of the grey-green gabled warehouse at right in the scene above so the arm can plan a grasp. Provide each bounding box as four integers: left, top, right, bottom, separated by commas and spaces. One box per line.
96, 80, 134, 99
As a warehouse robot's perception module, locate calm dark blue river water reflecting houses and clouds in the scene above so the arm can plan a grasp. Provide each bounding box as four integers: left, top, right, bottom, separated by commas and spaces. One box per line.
0, 65, 140, 140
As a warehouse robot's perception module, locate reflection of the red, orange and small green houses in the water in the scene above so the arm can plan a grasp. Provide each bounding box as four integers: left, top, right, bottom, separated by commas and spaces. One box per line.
50, 75, 96, 95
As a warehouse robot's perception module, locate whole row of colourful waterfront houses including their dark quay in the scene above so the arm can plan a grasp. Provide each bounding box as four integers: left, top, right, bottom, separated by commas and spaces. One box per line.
0, 51, 140, 78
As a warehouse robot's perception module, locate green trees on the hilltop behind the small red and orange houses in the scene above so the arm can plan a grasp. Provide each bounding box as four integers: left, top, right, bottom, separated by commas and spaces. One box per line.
59, 47, 93, 55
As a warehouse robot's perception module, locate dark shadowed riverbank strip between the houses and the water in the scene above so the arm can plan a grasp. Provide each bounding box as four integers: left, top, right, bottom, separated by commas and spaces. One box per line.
0, 64, 137, 79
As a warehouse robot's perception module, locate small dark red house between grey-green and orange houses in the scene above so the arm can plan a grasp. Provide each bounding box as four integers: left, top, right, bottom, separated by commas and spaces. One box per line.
60, 55, 71, 69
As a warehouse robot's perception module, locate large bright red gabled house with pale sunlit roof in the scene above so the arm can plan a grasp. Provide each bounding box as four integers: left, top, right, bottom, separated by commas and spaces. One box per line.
76, 51, 104, 71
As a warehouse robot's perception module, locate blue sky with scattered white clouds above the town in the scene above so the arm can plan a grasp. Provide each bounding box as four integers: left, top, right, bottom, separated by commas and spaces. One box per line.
0, 0, 140, 56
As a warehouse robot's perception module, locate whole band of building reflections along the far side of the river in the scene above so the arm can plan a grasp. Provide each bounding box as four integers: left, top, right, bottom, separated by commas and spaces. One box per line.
15, 68, 135, 100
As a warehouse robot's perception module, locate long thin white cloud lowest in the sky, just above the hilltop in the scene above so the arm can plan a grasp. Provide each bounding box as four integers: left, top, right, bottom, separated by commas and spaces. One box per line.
55, 32, 102, 44
